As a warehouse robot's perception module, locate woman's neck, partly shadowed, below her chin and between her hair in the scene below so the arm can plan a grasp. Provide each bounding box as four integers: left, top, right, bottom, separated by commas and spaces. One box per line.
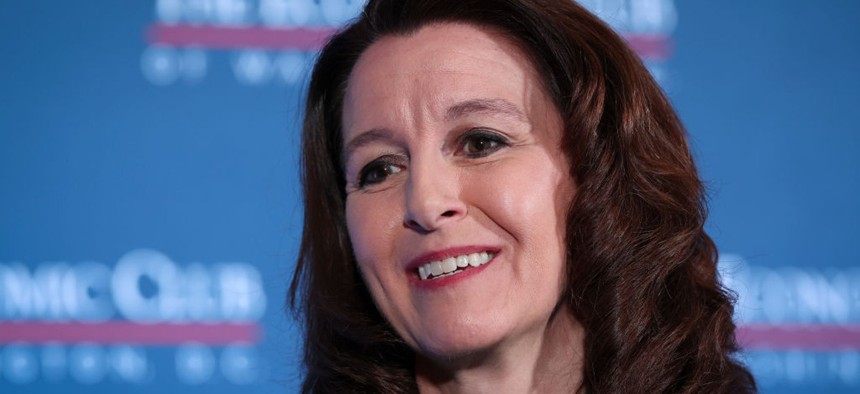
415, 308, 585, 394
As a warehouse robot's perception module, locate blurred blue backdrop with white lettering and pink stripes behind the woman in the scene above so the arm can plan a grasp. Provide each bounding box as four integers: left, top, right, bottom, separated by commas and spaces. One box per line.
0, 0, 860, 393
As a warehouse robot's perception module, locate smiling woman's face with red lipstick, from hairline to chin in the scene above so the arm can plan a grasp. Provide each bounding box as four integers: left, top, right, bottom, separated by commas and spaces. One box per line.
343, 23, 575, 358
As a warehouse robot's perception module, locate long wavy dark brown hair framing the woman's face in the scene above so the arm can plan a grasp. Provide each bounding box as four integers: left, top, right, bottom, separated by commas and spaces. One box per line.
289, 0, 756, 393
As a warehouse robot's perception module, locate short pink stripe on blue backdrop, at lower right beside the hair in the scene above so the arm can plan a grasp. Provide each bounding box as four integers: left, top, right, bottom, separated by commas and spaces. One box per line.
735, 324, 860, 351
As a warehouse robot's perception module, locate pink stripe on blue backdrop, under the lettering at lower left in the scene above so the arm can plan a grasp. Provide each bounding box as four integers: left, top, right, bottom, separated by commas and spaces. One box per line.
0, 321, 262, 345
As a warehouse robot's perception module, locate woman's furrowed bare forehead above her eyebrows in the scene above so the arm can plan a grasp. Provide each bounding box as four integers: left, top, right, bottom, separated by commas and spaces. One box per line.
343, 23, 540, 131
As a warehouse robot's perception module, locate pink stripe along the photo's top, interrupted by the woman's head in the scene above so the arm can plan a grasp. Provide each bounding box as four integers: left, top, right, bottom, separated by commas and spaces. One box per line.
147, 23, 673, 61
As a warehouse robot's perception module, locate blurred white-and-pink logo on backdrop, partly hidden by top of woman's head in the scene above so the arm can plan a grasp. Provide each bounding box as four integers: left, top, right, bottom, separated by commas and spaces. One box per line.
141, 0, 678, 86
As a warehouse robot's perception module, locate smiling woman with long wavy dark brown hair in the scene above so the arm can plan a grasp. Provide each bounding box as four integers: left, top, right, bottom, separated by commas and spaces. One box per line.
290, 0, 755, 393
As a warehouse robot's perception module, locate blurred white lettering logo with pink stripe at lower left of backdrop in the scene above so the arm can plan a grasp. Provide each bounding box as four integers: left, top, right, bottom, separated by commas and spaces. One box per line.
0, 249, 266, 384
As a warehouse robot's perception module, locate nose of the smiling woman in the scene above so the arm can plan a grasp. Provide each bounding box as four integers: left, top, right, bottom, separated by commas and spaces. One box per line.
403, 161, 466, 234
